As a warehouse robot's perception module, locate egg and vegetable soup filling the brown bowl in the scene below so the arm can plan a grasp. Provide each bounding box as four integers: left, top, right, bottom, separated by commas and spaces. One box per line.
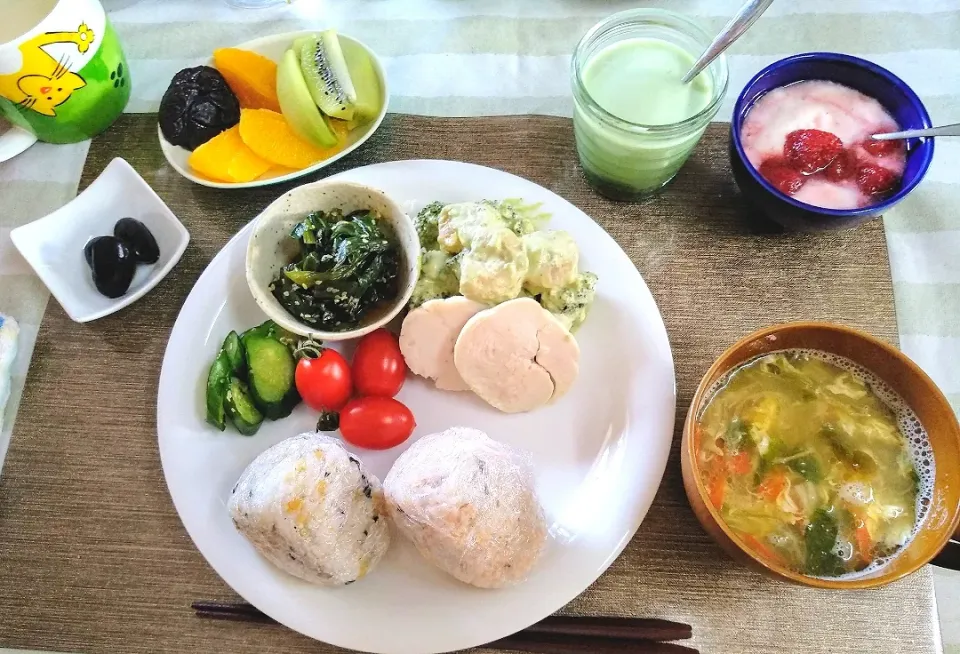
697, 351, 922, 577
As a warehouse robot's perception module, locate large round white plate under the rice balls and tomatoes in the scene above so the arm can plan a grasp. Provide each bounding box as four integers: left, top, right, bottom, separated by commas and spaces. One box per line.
157, 161, 676, 654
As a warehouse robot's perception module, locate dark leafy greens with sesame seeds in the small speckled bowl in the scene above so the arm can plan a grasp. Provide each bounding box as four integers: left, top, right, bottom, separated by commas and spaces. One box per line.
269, 209, 401, 331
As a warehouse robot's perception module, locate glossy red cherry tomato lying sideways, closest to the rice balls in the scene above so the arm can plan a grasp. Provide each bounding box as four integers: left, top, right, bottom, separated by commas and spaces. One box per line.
340, 395, 417, 450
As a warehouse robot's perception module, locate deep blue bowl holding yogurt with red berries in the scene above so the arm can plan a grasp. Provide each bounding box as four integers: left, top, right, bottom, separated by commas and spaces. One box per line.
730, 52, 933, 231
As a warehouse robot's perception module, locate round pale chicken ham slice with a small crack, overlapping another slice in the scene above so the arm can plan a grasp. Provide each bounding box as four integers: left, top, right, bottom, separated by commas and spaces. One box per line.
453, 298, 580, 413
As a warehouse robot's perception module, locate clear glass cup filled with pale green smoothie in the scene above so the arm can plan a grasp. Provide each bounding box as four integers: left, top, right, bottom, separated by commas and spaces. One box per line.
574, 38, 715, 198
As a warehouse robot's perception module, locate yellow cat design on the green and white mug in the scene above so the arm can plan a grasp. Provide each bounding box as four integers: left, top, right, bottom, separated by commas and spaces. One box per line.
0, 23, 95, 116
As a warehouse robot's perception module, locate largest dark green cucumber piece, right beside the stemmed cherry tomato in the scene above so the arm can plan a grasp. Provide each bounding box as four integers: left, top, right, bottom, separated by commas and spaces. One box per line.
242, 332, 300, 420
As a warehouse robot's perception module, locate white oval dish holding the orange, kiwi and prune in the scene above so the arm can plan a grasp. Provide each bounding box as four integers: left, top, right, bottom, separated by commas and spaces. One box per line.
157, 30, 390, 188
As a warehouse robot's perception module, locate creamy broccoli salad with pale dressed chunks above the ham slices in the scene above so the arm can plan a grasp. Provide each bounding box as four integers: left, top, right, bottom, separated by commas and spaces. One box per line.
410, 199, 597, 331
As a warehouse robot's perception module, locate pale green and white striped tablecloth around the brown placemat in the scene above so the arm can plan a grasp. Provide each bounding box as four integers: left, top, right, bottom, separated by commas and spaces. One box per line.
0, 0, 960, 654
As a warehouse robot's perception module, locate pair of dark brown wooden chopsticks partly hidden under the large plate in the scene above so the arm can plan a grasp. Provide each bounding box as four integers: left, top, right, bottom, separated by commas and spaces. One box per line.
191, 602, 697, 654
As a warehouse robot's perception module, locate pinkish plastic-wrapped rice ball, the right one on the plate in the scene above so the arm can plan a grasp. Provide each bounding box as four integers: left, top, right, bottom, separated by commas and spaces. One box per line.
383, 427, 547, 588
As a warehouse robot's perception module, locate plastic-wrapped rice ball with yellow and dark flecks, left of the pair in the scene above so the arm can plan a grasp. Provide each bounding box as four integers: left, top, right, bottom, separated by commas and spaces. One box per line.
227, 433, 390, 586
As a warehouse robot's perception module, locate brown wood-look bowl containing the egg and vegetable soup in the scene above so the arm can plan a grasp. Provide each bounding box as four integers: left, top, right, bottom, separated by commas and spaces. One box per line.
680, 322, 960, 589
